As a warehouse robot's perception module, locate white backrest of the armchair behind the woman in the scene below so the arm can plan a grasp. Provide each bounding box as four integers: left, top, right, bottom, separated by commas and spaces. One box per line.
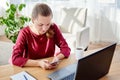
60, 8, 87, 33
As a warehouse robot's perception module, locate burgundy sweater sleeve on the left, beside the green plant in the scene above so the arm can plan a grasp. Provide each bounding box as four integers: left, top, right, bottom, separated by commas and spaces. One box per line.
12, 30, 28, 67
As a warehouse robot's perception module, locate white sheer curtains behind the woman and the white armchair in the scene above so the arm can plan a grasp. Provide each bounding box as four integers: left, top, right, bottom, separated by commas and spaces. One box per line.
8, 0, 120, 43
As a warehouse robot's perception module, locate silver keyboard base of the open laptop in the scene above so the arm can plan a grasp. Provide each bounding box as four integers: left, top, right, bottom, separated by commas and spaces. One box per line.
48, 63, 77, 80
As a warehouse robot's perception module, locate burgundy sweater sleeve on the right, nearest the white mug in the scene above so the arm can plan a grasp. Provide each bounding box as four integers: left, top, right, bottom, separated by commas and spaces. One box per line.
54, 24, 71, 57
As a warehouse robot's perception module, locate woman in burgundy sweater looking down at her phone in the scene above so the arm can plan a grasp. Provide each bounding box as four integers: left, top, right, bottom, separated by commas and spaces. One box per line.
12, 3, 70, 69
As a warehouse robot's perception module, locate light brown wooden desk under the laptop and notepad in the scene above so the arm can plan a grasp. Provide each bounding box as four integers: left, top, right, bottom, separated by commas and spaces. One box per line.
0, 50, 120, 80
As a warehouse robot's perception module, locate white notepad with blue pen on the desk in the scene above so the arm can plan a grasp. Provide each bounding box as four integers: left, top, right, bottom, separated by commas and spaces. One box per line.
10, 71, 37, 80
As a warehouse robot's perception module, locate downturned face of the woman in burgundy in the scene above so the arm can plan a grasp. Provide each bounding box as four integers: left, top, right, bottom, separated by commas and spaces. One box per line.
32, 15, 52, 34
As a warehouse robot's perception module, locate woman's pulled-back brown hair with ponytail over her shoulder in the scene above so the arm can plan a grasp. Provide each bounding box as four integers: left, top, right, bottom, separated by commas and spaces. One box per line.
32, 3, 54, 38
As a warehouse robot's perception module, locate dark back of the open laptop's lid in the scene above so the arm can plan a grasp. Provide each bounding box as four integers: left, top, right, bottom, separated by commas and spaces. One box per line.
74, 43, 116, 80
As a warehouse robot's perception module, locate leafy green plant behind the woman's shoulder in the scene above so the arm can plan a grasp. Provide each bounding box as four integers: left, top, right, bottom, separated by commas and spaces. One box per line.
0, 3, 30, 43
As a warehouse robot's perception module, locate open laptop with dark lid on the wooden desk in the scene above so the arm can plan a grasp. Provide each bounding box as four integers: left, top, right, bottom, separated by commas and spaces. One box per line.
48, 43, 116, 80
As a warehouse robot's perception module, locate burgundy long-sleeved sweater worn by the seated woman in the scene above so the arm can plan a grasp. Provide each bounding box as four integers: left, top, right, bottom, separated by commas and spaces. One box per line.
12, 24, 70, 67
